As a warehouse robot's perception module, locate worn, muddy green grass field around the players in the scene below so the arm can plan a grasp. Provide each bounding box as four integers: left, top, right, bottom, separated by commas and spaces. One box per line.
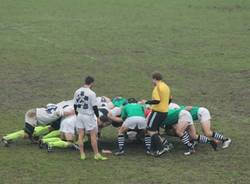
0, 0, 250, 184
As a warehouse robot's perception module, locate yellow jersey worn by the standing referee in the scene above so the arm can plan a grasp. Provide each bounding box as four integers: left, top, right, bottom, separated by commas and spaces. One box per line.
152, 81, 170, 112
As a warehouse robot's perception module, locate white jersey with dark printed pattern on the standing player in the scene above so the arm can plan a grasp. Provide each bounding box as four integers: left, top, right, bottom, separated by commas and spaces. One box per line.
74, 87, 97, 116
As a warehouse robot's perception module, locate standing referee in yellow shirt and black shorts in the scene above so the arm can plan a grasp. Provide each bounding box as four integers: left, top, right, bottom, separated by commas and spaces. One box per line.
145, 72, 170, 156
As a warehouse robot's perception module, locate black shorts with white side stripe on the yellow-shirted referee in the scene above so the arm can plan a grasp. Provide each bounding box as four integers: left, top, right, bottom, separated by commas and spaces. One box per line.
147, 111, 168, 132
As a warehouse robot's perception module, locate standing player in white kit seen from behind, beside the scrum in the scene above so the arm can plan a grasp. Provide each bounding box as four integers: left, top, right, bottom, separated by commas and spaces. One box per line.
74, 76, 107, 160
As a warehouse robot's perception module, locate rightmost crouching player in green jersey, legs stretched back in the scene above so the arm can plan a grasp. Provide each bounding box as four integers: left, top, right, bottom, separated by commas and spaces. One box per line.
170, 103, 232, 149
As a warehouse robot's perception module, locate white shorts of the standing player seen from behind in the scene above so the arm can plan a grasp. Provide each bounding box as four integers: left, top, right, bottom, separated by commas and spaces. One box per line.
76, 113, 98, 132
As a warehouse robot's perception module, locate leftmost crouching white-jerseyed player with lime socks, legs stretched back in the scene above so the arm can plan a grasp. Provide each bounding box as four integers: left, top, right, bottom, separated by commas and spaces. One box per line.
2, 100, 72, 146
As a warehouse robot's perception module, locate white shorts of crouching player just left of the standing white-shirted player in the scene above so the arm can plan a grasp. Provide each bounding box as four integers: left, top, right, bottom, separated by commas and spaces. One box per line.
60, 116, 76, 134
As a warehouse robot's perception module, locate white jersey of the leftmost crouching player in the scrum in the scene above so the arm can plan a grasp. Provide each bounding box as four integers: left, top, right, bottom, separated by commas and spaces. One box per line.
36, 108, 60, 125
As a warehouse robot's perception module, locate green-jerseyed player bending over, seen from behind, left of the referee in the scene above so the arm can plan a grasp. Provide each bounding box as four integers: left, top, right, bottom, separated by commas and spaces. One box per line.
110, 98, 147, 156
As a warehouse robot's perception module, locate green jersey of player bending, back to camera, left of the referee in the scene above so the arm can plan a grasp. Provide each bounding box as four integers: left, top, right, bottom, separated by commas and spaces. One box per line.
121, 103, 145, 120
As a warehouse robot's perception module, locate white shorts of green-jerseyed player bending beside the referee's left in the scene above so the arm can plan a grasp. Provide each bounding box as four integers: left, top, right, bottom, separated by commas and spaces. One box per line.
122, 116, 147, 130
